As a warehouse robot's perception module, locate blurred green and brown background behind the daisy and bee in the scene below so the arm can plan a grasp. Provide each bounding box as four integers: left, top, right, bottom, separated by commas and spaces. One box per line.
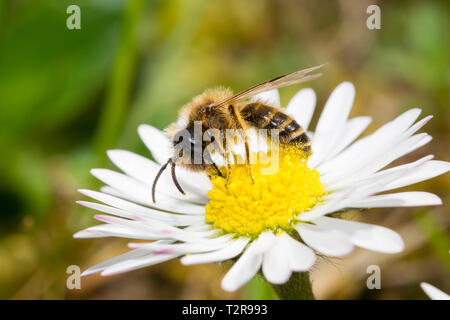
0, 0, 450, 299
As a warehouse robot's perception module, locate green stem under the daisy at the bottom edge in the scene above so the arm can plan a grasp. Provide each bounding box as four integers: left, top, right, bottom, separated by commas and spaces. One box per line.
272, 272, 314, 300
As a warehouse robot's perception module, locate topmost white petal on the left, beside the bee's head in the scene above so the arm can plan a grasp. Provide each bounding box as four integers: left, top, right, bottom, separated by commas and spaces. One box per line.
138, 124, 173, 164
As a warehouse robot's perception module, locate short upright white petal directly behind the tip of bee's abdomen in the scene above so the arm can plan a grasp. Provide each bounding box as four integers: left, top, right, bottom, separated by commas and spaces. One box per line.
286, 88, 316, 130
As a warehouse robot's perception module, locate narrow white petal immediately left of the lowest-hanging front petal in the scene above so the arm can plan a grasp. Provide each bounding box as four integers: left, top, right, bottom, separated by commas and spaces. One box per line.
181, 238, 250, 265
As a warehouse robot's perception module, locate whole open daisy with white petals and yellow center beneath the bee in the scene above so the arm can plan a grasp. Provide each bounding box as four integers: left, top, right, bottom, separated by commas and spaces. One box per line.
74, 82, 450, 291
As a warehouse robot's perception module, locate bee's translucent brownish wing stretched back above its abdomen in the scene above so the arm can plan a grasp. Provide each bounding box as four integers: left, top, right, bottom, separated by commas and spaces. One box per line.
216, 64, 323, 107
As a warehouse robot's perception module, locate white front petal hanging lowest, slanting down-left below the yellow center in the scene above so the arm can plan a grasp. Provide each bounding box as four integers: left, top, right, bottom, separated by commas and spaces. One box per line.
222, 232, 275, 291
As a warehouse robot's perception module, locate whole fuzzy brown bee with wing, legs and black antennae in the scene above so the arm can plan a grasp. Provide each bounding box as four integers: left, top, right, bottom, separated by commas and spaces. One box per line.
152, 65, 323, 202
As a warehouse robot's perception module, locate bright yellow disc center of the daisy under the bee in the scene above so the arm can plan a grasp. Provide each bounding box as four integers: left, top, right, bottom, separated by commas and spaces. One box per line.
205, 147, 324, 237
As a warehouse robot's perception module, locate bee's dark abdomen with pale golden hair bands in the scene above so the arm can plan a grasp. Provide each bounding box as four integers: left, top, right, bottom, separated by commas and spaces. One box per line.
240, 102, 311, 152
